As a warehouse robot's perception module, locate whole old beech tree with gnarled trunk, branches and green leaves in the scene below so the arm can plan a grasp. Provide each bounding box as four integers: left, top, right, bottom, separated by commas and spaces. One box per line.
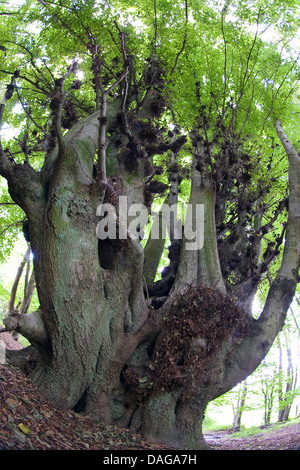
0, 0, 300, 449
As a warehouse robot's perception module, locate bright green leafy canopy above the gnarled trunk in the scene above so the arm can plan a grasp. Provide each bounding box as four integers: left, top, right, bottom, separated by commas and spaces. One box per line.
0, 0, 299, 272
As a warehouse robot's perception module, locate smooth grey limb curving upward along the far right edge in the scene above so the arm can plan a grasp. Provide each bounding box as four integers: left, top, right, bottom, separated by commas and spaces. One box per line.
220, 120, 300, 394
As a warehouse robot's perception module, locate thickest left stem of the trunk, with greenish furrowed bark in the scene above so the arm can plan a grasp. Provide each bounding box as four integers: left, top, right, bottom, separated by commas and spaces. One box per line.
1, 105, 147, 421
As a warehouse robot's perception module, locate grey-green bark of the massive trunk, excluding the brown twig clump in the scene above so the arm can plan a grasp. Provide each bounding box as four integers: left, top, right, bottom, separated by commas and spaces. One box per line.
0, 103, 300, 449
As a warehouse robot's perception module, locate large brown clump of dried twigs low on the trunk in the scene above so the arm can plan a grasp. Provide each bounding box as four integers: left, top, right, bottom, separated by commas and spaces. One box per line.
125, 286, 249, 400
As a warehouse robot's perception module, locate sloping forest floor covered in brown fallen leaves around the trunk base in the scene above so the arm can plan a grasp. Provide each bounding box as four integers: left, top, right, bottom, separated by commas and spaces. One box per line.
0, 334, 300, 451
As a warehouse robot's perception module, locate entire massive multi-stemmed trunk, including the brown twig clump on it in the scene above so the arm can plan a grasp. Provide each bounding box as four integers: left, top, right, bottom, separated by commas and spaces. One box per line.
1, 102, 300, 449
